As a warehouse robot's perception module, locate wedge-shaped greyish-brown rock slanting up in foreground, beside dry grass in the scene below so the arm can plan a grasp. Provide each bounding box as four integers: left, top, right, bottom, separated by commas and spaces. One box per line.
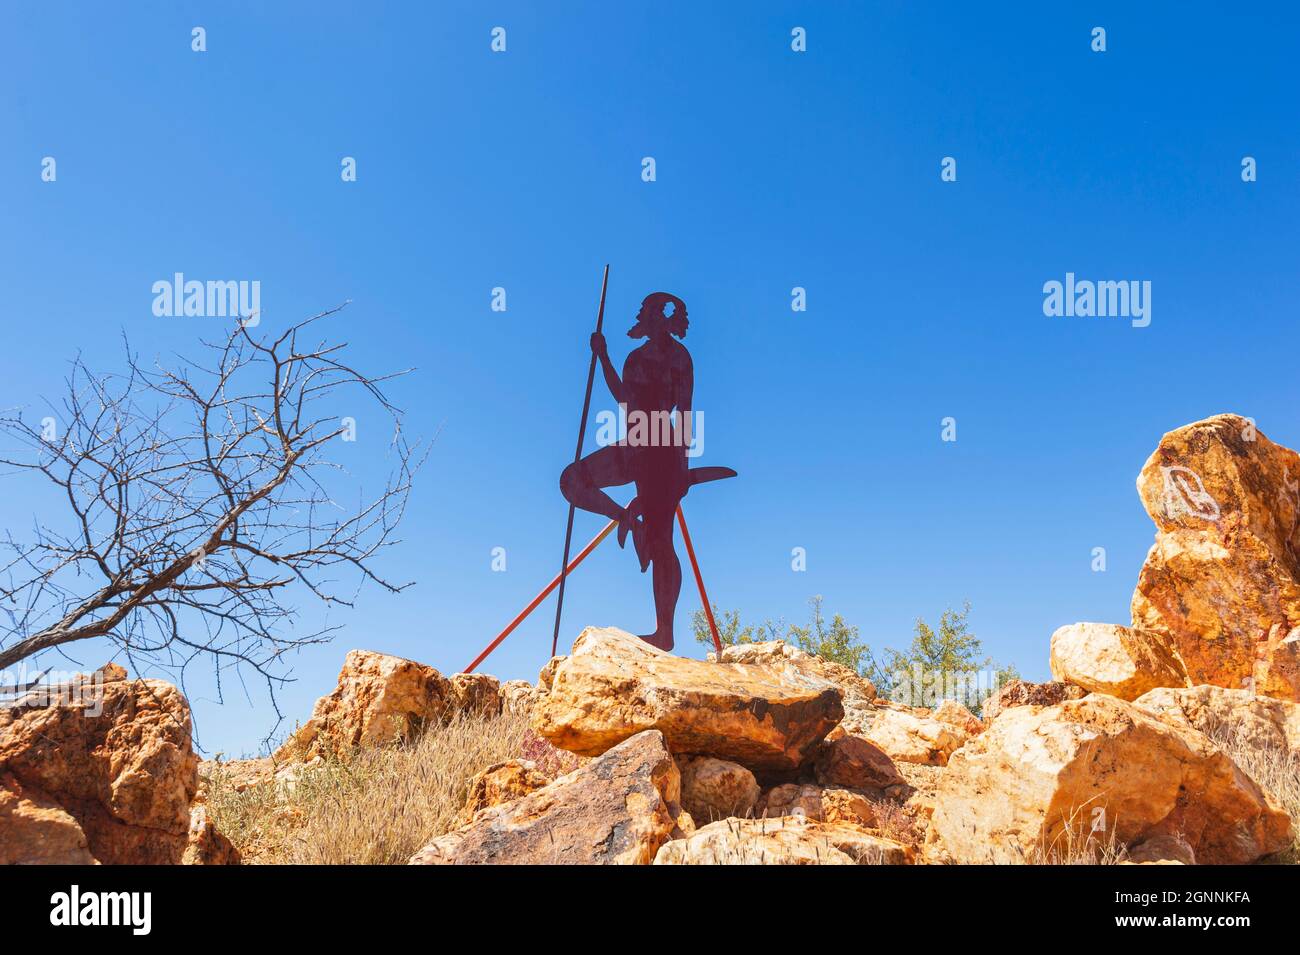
411, 730, 681, 865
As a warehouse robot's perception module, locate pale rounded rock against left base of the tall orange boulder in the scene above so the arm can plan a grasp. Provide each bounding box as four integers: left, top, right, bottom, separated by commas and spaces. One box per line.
1050, 624, 1187, 700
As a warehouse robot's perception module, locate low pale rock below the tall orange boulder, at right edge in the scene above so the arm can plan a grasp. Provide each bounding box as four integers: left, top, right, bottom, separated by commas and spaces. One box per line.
1136, 685, 1300, 752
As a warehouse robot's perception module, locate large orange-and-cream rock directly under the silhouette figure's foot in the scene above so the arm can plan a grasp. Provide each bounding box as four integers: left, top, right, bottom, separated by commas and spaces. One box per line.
532, 628, 844, 776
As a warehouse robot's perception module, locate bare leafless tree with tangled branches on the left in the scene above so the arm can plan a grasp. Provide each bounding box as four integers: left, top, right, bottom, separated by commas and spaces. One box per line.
0, 308, 419, 717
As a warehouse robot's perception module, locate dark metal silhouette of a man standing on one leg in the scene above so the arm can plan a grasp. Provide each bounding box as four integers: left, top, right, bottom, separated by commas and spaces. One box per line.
560, 292, 736, 650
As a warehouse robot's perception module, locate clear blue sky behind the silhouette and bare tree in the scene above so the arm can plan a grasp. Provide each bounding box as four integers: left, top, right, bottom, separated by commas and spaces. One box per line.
0, 3, 1300, 754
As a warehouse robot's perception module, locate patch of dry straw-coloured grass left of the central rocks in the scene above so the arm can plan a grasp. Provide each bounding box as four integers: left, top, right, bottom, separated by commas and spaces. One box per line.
207, 713, 530, 865
